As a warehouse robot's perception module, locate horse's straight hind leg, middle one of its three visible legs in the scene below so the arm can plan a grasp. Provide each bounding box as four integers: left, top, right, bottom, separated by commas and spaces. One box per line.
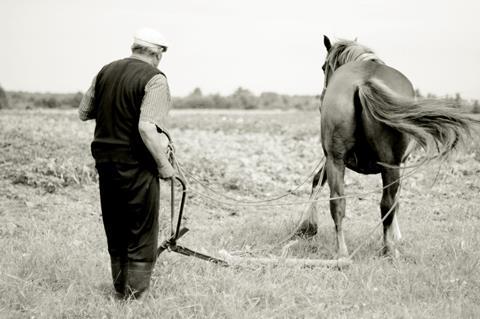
326, 156, 348, 257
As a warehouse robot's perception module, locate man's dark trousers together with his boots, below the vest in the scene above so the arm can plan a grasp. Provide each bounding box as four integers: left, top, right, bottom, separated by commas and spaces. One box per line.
96, 163, 159, 296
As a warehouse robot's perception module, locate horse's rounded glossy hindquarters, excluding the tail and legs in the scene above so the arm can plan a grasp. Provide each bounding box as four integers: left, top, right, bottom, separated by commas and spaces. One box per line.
322, 61, 413, 174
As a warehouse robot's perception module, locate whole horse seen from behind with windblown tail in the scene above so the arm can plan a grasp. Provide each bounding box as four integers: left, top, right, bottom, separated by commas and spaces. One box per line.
296, 36, 480, 257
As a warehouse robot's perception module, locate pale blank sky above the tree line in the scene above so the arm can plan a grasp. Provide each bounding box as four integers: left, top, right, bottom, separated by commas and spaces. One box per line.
0, 0, 480, 99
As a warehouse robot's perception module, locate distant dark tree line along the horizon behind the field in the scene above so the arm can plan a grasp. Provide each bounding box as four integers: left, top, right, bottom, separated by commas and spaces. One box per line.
0, 86, 480, 113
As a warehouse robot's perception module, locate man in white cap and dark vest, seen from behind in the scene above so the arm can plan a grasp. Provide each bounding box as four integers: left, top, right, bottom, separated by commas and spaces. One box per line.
78, 28, 174, 298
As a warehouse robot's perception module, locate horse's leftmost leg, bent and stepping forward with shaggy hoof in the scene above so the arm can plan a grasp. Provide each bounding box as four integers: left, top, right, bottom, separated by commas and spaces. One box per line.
295, 166, 325, 237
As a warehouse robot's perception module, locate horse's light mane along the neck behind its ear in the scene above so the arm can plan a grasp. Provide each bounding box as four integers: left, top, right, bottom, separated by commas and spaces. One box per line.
326, 40, 383, 71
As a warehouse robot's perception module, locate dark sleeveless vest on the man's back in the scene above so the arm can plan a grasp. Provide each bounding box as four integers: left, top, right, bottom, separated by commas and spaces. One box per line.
91, 58, 163, 169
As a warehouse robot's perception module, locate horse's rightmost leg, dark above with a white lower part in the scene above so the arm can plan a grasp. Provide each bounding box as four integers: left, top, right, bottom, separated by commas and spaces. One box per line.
380, 168, 400, 257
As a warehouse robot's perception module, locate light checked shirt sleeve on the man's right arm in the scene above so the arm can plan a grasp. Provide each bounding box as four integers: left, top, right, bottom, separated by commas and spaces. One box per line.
140, 74, 172, 131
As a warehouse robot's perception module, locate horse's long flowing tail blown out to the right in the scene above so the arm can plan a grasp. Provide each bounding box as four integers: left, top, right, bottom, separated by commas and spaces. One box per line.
358, 80, 480, 157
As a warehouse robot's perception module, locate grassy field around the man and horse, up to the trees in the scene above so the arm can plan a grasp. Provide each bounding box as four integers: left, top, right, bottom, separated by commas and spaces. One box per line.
0, 110, 480, 318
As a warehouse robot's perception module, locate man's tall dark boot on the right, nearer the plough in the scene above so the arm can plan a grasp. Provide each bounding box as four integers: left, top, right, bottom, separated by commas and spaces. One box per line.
126, 261, 155, 299
